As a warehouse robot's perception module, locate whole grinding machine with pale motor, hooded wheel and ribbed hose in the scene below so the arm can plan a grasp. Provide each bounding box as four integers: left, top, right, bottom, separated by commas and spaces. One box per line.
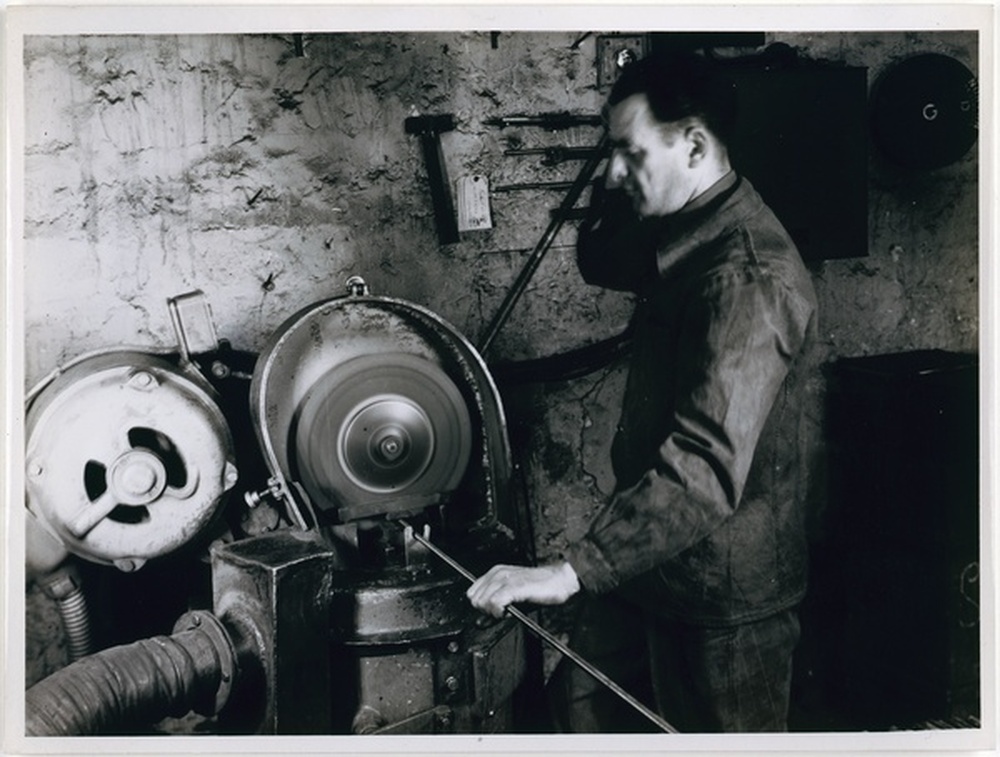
26, 277, 531, 735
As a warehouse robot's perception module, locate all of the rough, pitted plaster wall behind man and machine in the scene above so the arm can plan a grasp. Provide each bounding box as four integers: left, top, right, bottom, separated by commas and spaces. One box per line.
24, 33, 978, 679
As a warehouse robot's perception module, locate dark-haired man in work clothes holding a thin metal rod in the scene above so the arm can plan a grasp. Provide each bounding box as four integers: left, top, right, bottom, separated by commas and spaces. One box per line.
468, 55, 816, 732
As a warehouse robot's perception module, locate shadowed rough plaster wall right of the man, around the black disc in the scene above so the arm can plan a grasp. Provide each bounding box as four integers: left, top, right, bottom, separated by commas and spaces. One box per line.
780, 32, 979, 357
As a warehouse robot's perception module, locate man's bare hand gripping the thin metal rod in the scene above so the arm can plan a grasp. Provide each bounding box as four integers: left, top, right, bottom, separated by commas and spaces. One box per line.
465, 562, 580, 618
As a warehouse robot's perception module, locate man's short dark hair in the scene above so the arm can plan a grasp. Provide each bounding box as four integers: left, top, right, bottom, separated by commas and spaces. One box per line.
608, 53, 736, 144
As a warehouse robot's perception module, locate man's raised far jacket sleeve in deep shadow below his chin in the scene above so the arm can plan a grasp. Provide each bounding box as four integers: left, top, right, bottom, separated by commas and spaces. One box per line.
576, 186, 656, 292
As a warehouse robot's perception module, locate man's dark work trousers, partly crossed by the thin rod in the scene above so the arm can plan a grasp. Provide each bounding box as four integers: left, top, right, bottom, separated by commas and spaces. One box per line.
547, 594, 799, 733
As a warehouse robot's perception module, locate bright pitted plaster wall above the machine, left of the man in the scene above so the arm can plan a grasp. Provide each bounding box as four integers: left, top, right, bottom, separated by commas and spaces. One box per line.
19, 33, 620, 385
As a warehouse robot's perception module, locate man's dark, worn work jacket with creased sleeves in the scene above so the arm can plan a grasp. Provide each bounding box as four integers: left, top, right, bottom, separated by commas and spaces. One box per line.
566, 175, 816, 625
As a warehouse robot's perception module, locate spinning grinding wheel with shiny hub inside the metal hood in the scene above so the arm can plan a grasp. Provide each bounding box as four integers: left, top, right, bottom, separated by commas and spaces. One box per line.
292, 353, 472, 513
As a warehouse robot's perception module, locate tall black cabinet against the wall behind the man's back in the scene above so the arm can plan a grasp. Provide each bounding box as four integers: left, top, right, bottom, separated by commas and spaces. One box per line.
815, 350, 980, 729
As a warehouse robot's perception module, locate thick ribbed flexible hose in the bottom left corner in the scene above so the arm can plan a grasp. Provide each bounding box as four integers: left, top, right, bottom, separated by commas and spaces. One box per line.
25, 619, 234, 736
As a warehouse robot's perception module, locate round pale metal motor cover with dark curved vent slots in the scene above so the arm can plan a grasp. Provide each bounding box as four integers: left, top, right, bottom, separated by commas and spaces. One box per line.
26, 351, 237, 571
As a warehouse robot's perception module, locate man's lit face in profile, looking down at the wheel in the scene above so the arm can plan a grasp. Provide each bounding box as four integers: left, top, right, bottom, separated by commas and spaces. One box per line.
608, 94, 695, 218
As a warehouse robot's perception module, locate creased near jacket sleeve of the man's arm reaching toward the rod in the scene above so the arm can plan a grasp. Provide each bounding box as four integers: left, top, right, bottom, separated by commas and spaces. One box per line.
567, 271, 812, 592
